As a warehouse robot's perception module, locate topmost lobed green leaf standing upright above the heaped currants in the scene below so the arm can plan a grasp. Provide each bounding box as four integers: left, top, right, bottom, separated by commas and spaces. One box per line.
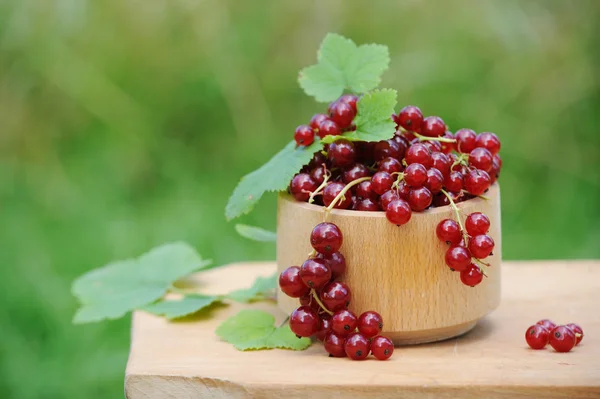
298, 33, 391, 103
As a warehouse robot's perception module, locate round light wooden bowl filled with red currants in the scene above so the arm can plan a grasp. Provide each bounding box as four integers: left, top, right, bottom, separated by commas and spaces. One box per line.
277, 184, 502, 345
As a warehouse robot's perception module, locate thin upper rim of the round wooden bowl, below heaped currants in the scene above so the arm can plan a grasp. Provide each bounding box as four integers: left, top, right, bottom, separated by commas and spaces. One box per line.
279, 182, 499, 218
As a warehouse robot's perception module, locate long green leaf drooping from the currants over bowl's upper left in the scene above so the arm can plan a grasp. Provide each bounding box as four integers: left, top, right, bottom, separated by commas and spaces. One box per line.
225, 140, 322, 220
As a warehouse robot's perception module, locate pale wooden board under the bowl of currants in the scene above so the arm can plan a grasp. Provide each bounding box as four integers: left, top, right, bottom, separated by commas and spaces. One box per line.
125, 261, 600, 399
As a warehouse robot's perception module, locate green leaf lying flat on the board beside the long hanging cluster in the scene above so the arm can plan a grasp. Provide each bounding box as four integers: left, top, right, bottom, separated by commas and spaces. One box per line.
216, 310, 311, 351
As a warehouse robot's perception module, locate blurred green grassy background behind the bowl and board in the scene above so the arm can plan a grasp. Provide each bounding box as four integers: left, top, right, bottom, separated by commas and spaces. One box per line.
0, 0, 600, 399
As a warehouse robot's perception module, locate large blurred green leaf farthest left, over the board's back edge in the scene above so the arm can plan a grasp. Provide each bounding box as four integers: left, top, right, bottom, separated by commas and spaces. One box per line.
72, 242, 210, 323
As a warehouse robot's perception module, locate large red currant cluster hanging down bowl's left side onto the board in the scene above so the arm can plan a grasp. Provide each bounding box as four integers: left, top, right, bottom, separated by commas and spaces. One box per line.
279, 223, 394, 360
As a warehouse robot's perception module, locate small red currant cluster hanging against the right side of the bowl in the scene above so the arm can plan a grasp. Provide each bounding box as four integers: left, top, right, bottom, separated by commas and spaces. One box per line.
435, 212, 494, 287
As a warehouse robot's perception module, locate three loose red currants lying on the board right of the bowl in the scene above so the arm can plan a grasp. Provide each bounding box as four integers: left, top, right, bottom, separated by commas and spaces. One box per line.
525, 319, 583, 352
